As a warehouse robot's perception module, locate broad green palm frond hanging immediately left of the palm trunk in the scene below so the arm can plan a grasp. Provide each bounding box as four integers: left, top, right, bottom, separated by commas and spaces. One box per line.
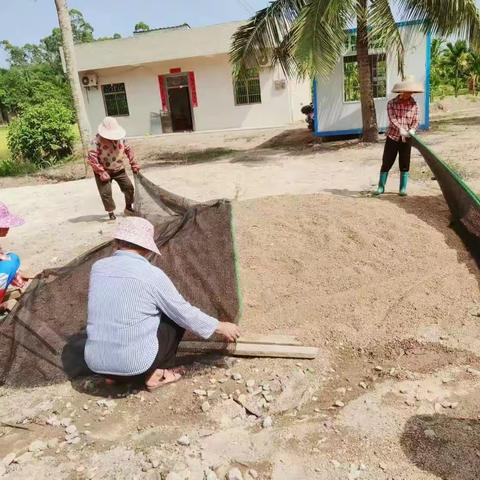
291, 0, 357, 77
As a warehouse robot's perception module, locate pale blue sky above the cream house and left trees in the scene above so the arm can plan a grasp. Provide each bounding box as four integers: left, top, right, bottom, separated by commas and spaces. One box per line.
0, 0, 269, 67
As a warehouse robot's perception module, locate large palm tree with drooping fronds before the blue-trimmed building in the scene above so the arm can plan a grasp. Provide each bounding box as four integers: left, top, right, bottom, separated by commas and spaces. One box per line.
230, 0, 480, 142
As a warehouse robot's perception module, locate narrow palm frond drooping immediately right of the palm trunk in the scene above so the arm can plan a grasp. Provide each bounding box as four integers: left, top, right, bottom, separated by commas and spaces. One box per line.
369, 0, 405, 77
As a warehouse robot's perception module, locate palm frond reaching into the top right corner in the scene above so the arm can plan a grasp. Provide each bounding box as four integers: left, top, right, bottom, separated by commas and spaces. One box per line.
395, 0, 480, 49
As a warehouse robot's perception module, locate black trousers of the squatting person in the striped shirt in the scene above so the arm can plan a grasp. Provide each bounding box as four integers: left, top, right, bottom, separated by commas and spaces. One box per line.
104, 314, 185, 383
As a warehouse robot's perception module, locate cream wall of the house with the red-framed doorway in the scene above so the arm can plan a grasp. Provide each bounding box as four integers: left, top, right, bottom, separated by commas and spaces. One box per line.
84, 55, 310, 136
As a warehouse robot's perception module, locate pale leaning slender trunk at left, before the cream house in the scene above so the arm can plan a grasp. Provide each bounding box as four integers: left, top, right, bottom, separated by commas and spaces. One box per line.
55, 0, 90, 172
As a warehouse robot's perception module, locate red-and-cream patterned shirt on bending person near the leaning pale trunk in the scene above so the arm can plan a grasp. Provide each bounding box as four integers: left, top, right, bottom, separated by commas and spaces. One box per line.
87, 135, 138, 175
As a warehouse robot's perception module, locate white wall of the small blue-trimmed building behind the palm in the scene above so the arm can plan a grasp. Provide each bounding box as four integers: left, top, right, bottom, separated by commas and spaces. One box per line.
316, 27, 427, 136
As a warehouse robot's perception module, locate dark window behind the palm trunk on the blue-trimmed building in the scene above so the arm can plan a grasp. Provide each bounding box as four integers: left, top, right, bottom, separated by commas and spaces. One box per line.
343, 53, 387, 102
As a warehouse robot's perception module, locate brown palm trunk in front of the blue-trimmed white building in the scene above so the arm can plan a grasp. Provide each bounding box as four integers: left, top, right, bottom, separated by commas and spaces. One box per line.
357, 0, 378, 142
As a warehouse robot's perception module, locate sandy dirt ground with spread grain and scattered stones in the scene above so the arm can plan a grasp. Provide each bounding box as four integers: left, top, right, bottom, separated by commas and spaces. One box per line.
0, 95, 480, 480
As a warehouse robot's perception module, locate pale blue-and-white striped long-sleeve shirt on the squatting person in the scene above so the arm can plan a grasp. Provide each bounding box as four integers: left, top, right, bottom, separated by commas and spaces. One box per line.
85, 251, 219, 376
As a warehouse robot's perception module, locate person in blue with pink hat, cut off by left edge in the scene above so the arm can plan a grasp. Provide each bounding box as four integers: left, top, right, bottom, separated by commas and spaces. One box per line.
0, 202, 25, 310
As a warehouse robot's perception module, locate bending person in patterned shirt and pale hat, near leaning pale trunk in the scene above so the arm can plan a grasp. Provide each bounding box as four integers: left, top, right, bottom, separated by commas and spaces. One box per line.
88, 117, 140, 220
